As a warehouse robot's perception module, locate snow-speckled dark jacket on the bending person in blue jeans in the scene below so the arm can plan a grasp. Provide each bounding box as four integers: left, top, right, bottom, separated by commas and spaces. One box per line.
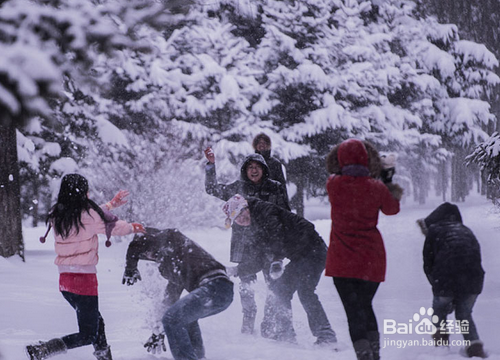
125, 228, 229, 305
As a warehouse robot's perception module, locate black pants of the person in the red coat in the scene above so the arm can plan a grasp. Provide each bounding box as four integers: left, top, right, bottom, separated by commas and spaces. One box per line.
333, 277, 380, 343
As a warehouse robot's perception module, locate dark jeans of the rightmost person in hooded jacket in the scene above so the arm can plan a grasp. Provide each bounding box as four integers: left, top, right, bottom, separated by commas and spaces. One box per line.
432, 294, 479, 341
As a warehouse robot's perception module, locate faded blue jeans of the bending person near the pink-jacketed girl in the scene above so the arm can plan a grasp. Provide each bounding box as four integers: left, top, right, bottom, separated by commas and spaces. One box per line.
162, 278, 233, 360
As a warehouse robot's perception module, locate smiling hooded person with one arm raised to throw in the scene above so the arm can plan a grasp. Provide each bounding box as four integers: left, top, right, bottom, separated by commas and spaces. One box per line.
205, 148, 290, 334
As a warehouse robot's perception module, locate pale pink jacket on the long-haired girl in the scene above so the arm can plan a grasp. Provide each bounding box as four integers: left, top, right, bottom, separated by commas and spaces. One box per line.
54, 206, 133, 274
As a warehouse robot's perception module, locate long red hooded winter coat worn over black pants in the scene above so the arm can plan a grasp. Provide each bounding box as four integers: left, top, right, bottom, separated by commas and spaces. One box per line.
326, 139, 399, 282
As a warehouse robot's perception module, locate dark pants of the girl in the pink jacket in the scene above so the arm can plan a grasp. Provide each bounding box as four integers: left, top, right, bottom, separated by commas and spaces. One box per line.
62, 291, 108, 350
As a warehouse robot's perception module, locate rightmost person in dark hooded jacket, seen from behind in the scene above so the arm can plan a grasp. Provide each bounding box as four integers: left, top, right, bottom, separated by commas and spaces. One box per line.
417, 202, 486, 357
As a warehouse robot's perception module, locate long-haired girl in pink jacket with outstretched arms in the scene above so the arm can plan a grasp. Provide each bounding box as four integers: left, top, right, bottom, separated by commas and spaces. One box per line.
26, 174, 145, 360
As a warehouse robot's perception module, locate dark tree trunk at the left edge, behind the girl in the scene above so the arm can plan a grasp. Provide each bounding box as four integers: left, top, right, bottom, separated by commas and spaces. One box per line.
0, 118, 24, 261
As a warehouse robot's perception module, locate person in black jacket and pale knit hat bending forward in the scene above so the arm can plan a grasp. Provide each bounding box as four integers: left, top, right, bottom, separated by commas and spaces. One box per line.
223, 194, 337, 345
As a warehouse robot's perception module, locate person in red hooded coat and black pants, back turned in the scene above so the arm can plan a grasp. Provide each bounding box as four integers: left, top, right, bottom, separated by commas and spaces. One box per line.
325, 139, 402, 360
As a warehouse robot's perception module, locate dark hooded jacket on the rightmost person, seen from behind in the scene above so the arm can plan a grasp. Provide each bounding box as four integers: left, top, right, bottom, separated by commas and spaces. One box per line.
423, 203, 484, 296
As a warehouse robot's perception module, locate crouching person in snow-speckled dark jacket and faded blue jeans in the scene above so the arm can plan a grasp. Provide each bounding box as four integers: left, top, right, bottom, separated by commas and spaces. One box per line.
122, 228, 233, 360
